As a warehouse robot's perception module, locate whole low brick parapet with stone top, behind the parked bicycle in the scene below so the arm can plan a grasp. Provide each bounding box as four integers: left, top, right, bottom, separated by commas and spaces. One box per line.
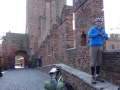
38, 63, 118, 90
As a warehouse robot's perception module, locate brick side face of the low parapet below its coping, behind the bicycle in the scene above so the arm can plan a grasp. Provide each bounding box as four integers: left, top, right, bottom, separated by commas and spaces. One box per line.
38, 64, 95, 90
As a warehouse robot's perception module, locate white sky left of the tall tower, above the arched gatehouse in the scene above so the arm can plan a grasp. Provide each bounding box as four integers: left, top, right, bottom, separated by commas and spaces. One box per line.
0, 0, 26, 36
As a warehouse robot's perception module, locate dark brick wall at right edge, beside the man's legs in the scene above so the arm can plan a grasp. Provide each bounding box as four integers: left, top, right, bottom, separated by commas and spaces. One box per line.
102, 49, 120, 85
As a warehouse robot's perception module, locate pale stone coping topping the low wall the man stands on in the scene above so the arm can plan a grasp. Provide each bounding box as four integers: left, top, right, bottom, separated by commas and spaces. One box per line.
40, 63, 119, 90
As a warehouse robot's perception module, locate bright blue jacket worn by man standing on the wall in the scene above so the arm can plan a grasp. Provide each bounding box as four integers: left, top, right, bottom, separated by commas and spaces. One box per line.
88, 26, 108, 46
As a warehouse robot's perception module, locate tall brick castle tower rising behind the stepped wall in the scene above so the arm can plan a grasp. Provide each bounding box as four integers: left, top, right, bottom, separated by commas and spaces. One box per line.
26, 0, 66, 55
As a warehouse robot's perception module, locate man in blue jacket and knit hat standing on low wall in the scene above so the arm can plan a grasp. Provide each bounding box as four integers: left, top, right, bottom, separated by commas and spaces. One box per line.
88, 17, 108, 84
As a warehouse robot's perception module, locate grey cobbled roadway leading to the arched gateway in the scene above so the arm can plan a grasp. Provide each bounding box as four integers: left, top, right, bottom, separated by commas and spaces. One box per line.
0, 68, 50, 90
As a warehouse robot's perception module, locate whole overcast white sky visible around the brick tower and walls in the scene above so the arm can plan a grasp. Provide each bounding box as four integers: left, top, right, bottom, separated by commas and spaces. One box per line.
0, 0, 120, 36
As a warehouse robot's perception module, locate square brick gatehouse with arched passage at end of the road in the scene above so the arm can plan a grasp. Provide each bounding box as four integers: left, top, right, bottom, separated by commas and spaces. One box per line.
2, 33, 29, 69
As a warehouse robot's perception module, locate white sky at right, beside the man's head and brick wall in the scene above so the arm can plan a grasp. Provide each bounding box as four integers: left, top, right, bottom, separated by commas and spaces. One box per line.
104, 0, 120, 34
